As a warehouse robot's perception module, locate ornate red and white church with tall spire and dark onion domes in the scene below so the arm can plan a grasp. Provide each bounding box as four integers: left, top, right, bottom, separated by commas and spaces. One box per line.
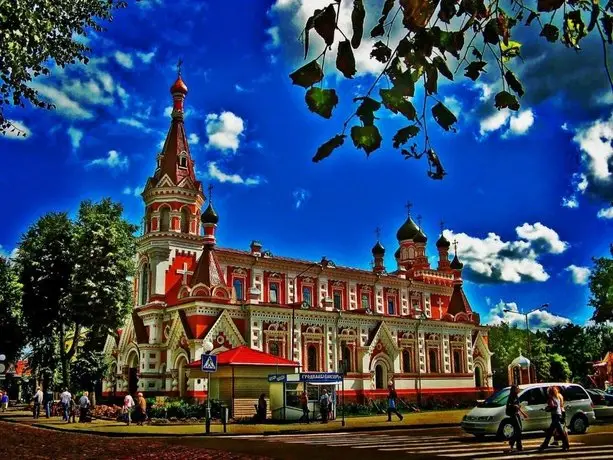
103, 75, 492, 399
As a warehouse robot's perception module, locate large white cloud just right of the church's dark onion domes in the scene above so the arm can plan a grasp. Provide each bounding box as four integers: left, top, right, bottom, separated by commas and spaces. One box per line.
444, 222, 568, 283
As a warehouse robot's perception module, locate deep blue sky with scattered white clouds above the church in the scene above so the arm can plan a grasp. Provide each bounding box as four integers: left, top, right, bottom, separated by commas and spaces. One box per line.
0, 0, 613, 327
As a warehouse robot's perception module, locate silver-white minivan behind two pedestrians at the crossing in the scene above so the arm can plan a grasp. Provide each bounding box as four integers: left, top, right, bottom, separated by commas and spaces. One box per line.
460, 383, 595, 439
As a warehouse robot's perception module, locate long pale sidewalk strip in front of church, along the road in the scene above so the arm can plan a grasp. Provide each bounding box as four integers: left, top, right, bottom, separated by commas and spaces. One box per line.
0, 409, 468, 437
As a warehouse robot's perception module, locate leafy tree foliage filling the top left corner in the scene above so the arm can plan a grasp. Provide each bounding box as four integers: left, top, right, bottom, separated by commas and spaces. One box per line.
0, 0, 127, 136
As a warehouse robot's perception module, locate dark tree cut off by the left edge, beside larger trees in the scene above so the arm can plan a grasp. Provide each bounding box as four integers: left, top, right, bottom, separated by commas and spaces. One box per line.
0, 256, 25, 362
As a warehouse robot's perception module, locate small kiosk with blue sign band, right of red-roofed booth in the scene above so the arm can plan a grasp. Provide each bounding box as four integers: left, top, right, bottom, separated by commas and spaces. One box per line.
268, 372, 343, 421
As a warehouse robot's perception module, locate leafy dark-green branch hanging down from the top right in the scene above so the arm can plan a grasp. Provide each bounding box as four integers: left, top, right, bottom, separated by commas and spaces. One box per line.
290, 0, 613, 180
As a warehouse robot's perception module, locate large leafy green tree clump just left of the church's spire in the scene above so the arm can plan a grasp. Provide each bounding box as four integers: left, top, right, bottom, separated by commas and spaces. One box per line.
18, 199, 137, 386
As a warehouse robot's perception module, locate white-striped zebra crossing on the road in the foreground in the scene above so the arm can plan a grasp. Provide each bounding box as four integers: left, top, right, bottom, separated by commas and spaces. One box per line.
251, 433, 613, 460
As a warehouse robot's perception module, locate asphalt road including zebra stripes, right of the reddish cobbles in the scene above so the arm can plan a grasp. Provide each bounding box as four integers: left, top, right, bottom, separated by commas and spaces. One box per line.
166, 426, 613, 460
